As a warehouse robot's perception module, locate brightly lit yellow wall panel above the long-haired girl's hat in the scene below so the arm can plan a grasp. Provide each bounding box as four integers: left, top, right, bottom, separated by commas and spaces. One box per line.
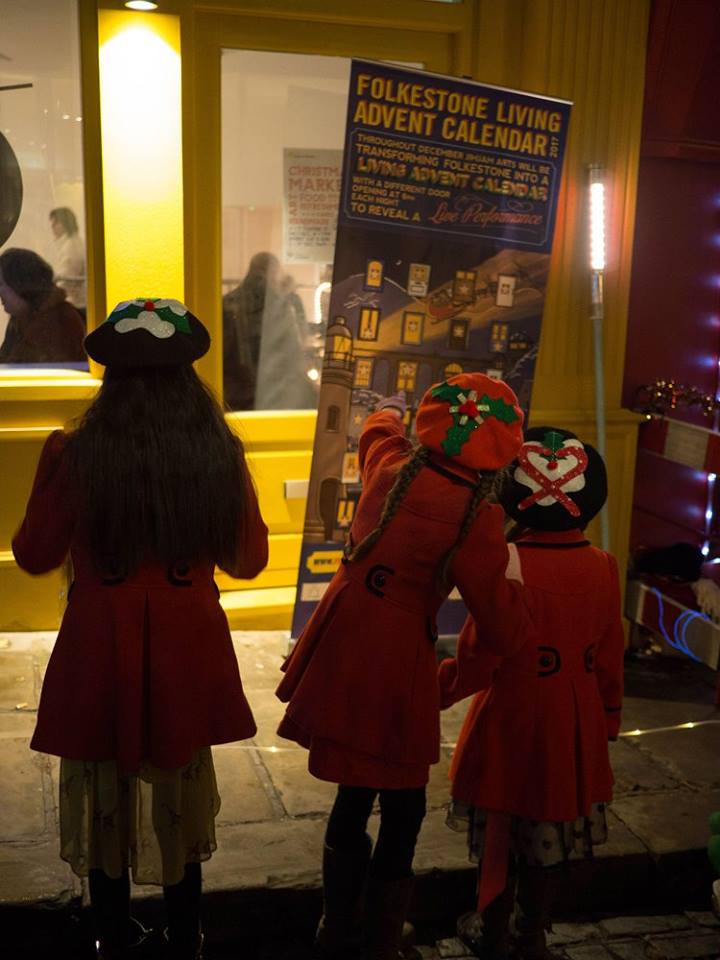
98, 9, 185, 309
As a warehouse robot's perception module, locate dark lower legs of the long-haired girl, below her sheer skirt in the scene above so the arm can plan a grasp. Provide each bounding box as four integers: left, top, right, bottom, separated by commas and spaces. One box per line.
88, 863, 202, 950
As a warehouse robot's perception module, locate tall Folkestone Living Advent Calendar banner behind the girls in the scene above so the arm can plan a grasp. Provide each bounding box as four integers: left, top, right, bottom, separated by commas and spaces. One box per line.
292, 61, 570, 636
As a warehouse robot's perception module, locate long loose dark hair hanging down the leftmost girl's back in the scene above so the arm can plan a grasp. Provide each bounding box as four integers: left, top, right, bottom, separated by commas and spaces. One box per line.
68, 365, 250, 575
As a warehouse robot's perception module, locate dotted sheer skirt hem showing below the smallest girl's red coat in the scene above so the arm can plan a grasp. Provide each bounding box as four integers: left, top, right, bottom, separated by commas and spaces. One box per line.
447, 800, 608, 867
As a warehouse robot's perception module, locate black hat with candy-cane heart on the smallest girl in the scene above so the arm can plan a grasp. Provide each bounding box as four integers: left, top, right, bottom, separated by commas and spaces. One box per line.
499, 427, 607, 531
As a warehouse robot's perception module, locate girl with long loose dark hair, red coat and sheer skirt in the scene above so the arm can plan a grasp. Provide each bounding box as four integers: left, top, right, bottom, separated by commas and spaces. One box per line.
13, 299, 267, 958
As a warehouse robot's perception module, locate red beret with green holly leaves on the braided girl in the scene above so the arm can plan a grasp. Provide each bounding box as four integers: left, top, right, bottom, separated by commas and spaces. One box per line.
415, 373, 523, 470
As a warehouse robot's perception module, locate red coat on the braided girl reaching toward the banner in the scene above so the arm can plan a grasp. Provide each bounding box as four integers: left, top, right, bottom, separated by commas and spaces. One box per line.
277, 411, 527, 788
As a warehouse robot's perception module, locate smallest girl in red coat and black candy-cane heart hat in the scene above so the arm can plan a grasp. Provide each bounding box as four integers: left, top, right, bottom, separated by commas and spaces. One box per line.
440, 427, 624, 960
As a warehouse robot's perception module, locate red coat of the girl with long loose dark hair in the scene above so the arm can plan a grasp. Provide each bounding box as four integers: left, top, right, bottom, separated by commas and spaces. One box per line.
13, 430, 267, 771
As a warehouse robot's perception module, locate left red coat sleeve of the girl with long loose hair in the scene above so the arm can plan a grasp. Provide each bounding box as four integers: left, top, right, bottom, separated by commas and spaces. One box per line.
12, 430, 75, 574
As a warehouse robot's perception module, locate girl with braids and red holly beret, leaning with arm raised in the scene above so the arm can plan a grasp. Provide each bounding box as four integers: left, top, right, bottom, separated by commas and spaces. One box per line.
278, 373, 536, 960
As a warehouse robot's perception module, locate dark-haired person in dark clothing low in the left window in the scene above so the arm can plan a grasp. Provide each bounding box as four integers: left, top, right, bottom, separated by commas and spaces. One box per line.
0, 247, 87, 364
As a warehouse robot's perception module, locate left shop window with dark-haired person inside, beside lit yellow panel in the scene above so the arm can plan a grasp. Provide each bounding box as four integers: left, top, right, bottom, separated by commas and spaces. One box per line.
0, 0, 88, 370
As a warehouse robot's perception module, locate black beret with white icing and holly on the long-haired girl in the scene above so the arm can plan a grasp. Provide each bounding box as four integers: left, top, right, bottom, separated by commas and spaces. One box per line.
85, 297, 210, 367
